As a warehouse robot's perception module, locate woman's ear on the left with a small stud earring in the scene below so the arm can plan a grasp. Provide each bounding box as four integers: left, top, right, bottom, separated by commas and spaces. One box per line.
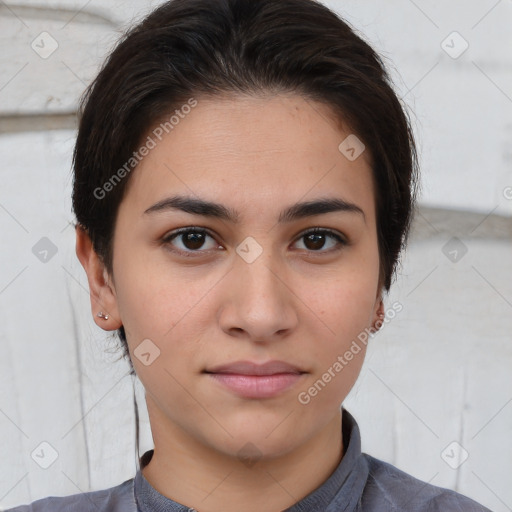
75, 224, 123, 331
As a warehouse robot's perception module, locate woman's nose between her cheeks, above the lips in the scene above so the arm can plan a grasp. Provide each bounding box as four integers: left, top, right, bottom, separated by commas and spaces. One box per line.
219, 244, 298, 343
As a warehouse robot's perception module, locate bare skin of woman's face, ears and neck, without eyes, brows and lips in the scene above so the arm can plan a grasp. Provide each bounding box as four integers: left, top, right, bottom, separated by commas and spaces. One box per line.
76, 95, 383, 512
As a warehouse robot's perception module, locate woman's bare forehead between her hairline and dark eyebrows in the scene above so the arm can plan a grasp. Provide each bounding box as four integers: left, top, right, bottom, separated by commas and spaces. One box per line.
123, 95, 373, 222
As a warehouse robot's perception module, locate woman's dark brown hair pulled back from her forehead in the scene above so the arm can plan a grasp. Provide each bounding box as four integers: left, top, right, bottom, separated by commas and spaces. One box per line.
73, 0, 418, 373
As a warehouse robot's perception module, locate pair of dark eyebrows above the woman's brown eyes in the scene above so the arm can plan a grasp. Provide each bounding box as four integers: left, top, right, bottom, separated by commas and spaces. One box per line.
144, 196, 366, 224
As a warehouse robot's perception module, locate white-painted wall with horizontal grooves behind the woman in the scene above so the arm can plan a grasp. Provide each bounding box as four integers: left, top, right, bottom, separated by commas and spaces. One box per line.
0, 0, 512, 512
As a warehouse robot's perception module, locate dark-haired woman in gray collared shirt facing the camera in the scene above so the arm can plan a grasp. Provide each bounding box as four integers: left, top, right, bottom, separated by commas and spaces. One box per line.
4, 0, 488, 512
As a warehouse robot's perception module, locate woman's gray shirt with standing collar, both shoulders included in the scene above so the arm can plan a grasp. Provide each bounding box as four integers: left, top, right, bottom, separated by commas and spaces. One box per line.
7, 409, 491, 512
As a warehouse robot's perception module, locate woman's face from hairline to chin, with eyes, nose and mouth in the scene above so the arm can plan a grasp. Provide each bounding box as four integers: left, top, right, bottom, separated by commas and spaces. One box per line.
78, 95, 381, 457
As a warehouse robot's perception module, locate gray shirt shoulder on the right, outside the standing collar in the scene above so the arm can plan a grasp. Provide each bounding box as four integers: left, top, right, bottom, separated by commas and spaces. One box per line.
362, 453, 491, 512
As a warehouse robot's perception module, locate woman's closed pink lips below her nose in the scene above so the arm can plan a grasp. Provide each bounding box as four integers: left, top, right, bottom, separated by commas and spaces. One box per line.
205, 361, 305, 398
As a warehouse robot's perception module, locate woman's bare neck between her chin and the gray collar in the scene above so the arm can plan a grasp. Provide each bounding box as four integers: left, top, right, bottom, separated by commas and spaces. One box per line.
142, 403, 344, 512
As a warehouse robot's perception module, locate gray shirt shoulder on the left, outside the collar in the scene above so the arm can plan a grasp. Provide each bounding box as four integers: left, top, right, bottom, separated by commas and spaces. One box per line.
5, 478, 137, 512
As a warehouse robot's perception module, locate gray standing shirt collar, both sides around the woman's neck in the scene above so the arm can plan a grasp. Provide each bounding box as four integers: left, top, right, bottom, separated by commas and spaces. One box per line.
135, 408, 369, 512
